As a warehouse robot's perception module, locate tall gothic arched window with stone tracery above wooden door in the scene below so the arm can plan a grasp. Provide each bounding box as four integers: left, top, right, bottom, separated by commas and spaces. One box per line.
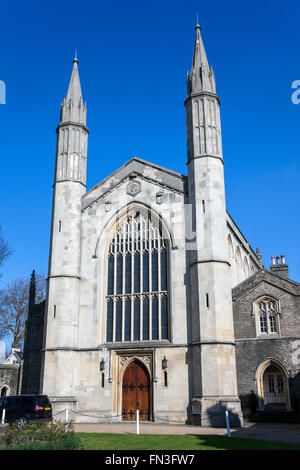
106, 211, 169, 342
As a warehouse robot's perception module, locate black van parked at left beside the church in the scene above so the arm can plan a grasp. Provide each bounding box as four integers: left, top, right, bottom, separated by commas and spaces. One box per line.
0, 395, 52, 429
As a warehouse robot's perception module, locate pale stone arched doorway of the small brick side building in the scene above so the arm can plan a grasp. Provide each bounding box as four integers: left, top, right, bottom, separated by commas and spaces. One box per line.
256, 358, 291, 410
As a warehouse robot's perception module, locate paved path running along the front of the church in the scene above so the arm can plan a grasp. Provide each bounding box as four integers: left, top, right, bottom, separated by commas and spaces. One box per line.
74, 423, 300, 444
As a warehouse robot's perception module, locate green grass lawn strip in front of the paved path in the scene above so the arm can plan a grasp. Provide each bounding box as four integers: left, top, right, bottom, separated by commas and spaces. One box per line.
76, 432, 300, 450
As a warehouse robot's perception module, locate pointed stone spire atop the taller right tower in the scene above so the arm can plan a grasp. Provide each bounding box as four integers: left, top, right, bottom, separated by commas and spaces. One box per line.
187, 23, 216, 95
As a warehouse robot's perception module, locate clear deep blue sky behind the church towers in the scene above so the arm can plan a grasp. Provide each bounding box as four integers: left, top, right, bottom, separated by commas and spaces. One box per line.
0, 0, 300, 286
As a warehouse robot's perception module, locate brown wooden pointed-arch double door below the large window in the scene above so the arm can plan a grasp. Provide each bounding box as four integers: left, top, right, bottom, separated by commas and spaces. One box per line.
122, 360, 150, 421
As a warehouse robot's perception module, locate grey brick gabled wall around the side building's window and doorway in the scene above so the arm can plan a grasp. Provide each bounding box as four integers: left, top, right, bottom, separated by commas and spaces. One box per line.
233, 269, 300, 411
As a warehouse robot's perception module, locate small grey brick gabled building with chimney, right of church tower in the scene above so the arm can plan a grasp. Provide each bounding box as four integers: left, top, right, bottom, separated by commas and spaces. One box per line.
232, 256, 300, 414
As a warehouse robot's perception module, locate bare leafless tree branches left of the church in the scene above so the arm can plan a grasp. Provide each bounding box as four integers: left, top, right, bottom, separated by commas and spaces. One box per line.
0, 274, 46, 348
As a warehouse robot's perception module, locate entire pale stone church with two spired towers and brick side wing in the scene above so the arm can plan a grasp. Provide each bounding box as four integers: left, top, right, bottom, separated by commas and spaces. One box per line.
23, 25, 300, 426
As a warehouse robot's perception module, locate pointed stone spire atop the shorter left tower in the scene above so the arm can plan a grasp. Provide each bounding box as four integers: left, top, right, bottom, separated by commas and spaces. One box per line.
61, 54, 86, 125
